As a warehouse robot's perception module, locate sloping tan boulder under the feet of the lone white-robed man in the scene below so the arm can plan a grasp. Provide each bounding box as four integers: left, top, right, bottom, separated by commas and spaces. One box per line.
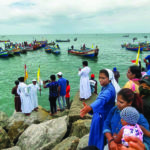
68, 92, 97, 126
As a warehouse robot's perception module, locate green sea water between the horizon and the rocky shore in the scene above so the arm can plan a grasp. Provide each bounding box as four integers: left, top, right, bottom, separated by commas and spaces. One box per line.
0, 33, 150, 116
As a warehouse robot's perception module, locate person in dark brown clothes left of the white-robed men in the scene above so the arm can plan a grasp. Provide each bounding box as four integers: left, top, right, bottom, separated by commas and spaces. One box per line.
11, 80, 21, 112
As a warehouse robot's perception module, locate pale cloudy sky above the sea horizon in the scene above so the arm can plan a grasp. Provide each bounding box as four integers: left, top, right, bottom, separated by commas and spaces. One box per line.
0, 0, 150, 35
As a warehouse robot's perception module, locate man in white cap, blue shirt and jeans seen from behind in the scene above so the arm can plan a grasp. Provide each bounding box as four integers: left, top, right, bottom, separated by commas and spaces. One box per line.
57, 72, 67, 111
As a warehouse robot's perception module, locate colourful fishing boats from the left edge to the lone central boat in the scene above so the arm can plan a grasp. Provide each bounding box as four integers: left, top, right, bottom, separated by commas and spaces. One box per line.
0, 38, 99, 58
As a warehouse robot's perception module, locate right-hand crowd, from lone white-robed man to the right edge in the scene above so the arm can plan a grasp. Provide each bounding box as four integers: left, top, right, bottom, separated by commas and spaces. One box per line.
79, 59, 150, 150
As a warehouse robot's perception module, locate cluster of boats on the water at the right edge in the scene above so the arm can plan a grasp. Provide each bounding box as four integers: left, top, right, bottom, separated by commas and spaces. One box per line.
121, 42, 150, 51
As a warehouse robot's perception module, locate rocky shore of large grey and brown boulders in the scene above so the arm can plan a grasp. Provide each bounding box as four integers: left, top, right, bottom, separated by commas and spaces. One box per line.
0, 93, 97, 150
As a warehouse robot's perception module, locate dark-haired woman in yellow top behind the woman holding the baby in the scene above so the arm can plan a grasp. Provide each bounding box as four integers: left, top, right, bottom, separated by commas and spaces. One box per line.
123, 66, 142, 93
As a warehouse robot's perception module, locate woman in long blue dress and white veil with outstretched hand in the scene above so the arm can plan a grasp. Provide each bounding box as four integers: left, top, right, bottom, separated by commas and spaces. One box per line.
80, 69, 120, 150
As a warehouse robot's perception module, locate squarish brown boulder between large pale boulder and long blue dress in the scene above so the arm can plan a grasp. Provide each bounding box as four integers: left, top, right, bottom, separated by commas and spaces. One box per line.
70, 119, 91, 138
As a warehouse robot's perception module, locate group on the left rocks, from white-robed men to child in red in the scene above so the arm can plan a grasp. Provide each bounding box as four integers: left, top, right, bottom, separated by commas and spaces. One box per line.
12, 72, 70, 116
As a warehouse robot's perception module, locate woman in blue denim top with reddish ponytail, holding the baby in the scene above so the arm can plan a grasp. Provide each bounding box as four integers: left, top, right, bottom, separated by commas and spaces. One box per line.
103, 88, 150, 150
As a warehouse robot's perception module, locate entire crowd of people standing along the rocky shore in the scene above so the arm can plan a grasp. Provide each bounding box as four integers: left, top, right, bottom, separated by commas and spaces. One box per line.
12, 57, 150, 150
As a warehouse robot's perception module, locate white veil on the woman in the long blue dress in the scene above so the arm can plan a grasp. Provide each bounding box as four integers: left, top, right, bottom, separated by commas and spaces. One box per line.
105, 69, 120, 102
